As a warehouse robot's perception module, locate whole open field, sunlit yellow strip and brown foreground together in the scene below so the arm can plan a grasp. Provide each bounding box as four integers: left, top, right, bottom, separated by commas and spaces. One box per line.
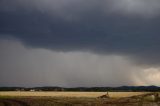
0, 92, 160, 106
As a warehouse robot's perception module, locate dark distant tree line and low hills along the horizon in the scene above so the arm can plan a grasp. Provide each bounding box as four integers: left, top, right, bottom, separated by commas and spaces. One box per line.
0, 86, 160, 92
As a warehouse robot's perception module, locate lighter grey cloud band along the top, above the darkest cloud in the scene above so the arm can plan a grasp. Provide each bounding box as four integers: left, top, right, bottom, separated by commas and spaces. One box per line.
1, 0, 160, 18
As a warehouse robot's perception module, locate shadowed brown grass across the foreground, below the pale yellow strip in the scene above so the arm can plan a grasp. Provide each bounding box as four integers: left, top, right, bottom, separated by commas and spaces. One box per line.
0, 97, 159, 106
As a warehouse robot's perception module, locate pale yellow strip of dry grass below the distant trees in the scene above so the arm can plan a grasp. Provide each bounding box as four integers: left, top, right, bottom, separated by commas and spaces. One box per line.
0, 91, 145, 98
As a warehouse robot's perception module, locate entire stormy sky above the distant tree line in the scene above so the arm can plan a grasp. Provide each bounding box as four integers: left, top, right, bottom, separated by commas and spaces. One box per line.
0, 0, 160, 87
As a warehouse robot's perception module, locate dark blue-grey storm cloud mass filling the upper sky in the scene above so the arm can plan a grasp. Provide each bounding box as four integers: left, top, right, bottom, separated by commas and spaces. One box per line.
0, 0, 160, 64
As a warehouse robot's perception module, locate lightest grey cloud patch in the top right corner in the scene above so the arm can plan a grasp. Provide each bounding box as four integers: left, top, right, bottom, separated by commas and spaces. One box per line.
110, 0, 160, 17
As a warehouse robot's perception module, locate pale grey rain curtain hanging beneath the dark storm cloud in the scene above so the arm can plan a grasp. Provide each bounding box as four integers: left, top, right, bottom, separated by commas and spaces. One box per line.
0, 40, 141, 87
